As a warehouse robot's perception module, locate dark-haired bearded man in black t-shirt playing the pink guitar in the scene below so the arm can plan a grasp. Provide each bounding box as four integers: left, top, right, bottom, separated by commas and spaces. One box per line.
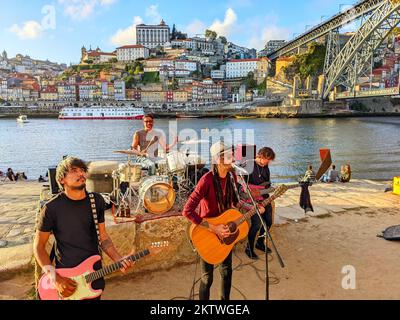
34, 157, 132, 299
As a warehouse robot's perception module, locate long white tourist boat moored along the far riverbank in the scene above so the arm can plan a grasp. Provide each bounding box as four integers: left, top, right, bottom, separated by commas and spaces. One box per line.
58, 106, 144, 120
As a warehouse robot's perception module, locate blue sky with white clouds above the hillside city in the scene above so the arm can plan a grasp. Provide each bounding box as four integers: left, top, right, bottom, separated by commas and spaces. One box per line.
0, 0, 355, 64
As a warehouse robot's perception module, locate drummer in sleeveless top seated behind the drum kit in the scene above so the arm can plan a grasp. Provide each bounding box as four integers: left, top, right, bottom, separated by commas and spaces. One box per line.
132, 114, 178, 176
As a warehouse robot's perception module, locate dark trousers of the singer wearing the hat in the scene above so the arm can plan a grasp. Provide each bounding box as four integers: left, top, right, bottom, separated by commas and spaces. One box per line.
199, 251, 232, 300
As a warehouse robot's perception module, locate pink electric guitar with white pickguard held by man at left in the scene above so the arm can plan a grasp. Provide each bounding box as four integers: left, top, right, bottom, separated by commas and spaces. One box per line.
38, 241, 169, 300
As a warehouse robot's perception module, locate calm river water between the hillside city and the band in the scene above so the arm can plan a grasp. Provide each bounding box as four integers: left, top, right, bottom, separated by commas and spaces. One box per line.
0, 117, 400, 182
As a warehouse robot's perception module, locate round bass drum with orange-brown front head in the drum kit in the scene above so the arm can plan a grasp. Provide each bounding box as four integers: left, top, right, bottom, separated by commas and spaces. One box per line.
139, 176, 176, 214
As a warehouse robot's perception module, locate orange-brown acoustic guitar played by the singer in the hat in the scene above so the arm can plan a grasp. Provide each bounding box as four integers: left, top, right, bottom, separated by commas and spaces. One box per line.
189, 185, 287, 264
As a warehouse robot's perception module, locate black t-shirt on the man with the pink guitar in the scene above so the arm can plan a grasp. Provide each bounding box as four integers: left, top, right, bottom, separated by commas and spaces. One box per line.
38, 193, 105, 289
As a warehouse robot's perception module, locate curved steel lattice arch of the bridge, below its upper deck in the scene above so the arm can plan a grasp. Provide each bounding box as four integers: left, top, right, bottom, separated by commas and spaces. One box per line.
323, 0, 400, 99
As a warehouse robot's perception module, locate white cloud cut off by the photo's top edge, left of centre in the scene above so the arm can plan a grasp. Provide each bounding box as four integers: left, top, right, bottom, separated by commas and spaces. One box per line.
58, 0, 117, 20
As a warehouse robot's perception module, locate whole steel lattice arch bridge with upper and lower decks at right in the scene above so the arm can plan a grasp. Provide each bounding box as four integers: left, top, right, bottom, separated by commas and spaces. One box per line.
268, 0, 400, 100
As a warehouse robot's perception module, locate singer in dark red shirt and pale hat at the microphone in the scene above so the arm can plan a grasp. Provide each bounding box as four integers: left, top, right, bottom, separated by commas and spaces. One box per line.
182, 141, 264, 300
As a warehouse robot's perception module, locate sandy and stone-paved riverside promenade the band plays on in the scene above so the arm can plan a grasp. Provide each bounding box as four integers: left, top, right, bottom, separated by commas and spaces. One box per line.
0, 180, 400, 300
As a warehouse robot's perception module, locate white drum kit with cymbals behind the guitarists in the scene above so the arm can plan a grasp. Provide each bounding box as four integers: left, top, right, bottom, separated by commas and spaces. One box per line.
110, 140, 208, 222
